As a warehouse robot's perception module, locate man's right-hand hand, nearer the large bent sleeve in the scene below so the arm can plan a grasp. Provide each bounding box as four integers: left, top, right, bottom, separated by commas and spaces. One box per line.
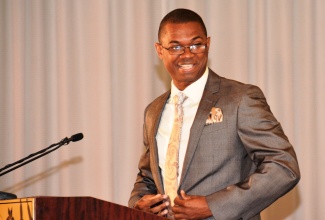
172, 190, 212, 219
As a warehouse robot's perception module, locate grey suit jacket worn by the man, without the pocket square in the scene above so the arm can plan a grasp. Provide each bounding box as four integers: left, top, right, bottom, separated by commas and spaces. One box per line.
129, 69, 300, 220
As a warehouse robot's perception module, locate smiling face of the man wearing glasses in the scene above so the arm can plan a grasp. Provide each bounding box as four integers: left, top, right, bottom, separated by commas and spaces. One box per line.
155, 22, 210, 90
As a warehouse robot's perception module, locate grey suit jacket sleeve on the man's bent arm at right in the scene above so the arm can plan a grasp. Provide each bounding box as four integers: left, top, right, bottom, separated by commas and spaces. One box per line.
206, 85, 300, 219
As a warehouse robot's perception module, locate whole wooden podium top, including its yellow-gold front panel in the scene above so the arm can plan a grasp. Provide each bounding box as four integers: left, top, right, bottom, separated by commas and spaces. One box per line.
0, 196, 166, 220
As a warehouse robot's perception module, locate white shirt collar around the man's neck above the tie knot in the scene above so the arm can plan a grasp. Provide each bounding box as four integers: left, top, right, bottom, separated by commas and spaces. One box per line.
169, 67, 209, 103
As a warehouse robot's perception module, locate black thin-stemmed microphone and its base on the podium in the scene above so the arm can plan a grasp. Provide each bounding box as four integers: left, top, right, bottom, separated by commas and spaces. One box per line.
0, 133, 84, 200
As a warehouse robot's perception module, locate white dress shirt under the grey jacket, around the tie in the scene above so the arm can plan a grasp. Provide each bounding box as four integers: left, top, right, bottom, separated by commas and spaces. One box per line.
156, 68, 209, 186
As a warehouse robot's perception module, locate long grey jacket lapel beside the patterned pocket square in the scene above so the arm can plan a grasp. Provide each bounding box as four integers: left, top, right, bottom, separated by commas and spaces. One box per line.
179, 69, 220, 189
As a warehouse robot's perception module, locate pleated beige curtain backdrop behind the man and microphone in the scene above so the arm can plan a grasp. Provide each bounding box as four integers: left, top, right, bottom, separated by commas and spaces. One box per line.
0, 0, 325, 220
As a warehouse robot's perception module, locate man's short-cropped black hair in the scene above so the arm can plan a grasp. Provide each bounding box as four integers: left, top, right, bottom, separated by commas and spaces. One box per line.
158, 8, 208, 41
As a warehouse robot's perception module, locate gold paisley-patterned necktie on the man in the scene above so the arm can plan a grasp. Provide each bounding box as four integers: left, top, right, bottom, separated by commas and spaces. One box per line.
164, 92, 187, 206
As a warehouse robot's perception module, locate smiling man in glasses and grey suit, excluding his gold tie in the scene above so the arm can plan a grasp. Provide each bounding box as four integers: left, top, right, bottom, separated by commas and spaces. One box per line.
129, 9, 300, 220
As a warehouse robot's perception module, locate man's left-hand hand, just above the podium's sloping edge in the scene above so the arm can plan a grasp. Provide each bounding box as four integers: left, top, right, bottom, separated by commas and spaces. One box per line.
134, 194, 170, 216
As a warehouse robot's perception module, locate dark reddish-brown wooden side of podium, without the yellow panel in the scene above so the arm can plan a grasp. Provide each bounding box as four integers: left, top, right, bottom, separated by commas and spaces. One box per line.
34, 197, 166, 220
